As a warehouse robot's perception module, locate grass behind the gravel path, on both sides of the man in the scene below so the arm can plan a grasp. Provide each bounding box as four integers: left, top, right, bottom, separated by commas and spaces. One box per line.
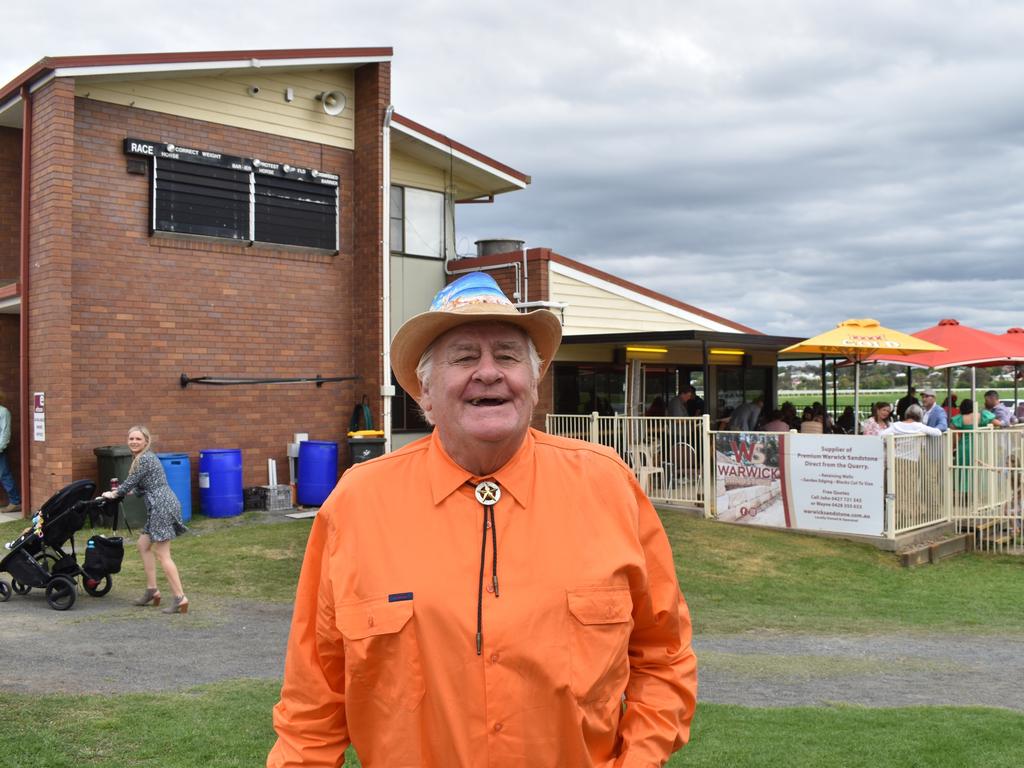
0, 510, 1024, 633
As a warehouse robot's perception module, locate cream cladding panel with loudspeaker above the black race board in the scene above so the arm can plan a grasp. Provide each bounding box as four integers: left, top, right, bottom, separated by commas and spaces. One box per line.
76, 70, 355, 150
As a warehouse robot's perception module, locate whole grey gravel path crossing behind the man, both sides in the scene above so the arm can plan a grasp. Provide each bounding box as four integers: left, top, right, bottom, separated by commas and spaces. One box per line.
0, 582, 1024, 712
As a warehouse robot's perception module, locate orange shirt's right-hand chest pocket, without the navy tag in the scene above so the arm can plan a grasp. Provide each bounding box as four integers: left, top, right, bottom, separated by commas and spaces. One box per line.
566, 587, 633, 703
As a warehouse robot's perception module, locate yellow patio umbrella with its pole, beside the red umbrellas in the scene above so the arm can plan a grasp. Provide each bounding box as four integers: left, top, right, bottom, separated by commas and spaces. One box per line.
779, 317, 945, 434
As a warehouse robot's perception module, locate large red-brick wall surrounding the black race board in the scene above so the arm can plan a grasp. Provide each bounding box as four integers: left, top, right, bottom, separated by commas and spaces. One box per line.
20, 87, 380, 502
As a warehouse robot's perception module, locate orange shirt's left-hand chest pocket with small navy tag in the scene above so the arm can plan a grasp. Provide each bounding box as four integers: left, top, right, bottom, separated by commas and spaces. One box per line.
335, 597, 424, 711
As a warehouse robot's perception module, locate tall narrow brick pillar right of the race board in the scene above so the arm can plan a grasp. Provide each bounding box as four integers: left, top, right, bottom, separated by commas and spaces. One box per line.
348, 63, 391, 425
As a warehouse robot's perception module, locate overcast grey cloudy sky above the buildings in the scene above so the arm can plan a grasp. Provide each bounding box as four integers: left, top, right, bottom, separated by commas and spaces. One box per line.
0, 0, 1024, 336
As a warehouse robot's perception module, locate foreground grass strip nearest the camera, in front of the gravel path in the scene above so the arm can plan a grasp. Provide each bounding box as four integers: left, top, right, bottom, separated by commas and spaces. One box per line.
0, 680, 1024, 768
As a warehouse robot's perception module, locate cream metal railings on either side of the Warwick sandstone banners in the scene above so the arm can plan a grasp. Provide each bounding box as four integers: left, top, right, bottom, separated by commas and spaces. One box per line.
546, 413, 1024, 554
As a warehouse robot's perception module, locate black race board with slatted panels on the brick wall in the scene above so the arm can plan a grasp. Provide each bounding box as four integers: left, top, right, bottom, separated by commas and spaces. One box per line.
124, 138, 339, 251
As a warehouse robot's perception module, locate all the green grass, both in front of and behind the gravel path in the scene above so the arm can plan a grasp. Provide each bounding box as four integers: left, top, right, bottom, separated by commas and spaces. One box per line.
0, 511, 1024, 768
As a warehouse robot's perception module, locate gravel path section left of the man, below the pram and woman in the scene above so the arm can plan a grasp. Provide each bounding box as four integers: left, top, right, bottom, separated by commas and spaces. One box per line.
0, 589, 292, 693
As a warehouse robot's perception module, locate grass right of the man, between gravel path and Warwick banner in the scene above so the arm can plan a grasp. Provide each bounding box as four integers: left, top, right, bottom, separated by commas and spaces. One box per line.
662, 511, 1024, 634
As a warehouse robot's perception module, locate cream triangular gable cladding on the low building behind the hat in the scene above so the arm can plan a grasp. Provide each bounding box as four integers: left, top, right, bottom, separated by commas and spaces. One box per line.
549, 270, 706, 335
